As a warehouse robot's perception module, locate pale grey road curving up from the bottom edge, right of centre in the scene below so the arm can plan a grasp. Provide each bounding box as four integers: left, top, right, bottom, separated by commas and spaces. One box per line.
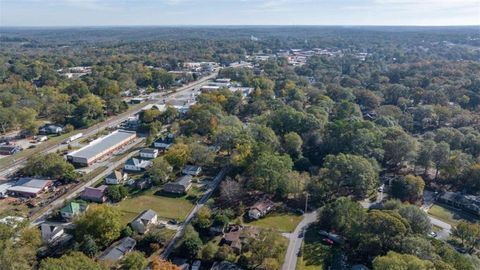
282, 211, 317, 270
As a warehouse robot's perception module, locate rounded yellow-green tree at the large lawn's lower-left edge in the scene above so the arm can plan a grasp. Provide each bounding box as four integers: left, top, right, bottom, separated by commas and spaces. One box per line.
74, 205, 123, 247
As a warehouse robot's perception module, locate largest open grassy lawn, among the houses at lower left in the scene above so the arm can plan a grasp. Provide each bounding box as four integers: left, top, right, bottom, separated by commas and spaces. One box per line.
113, 189, 193, 224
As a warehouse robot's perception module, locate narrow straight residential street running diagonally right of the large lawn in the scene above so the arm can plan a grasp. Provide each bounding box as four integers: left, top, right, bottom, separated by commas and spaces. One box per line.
160, 167, 228, 259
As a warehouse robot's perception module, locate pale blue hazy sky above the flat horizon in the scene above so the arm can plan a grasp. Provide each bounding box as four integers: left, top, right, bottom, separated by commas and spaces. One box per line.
0, 0, 480, 26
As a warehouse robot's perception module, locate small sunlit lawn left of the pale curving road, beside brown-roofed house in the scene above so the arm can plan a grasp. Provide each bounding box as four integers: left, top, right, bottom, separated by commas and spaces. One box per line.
248, 213, 302, 232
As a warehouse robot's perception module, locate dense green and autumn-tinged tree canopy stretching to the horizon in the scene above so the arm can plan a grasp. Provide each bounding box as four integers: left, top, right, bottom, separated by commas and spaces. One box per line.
0, 27, 480, 270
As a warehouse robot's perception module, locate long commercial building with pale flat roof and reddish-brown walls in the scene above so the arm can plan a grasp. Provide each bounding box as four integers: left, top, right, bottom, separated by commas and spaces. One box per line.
67, 130, 137, 166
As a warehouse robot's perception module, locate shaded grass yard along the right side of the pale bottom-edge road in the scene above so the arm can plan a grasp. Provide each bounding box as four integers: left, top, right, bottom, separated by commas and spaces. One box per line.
296, 226, 330, 270
